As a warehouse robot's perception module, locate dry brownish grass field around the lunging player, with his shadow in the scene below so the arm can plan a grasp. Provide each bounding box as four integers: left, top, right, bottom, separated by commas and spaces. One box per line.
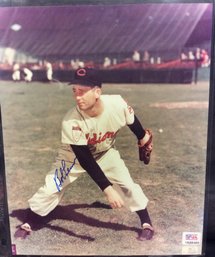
0, 82, 209, 255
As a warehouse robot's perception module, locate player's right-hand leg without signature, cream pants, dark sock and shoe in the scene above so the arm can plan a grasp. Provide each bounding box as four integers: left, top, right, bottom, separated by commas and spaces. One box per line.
99, 149, 154, 240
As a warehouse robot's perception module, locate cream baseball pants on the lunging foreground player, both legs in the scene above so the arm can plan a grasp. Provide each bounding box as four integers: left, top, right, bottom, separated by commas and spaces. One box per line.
28, 145, 148, 216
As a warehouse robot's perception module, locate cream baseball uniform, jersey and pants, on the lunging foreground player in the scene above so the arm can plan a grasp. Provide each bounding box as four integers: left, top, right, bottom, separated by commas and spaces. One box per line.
29, 95, 148, 216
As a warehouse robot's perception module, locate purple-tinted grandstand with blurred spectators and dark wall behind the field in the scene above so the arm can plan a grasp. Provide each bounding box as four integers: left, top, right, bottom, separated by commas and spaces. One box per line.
0, 3, 212, 83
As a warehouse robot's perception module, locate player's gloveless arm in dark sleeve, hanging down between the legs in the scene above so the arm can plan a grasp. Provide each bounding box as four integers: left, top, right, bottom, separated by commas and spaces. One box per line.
71, 145, 124, 208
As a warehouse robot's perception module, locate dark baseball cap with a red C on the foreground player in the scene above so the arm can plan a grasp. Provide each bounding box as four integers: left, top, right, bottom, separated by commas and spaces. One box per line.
69, 67, 102, 87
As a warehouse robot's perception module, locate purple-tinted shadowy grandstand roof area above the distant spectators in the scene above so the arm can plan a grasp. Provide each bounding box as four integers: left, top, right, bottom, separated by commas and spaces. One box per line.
0, 3, 212, 57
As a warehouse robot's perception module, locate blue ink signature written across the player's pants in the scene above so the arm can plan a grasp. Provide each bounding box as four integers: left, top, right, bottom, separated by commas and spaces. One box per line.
54, 158, 77, 192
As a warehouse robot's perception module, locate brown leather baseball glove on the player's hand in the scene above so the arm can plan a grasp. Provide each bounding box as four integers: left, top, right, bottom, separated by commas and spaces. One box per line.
138, 129, 152, 164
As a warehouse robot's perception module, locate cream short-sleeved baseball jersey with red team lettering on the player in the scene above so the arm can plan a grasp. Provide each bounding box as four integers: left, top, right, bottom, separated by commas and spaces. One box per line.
62, 95, 134, 157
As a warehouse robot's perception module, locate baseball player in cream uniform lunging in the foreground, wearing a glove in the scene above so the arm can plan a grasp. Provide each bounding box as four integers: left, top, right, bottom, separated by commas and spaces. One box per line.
17, 68, 154, 240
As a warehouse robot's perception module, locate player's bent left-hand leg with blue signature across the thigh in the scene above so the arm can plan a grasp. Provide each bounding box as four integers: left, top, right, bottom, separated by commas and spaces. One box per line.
15, 145, 84, 235
